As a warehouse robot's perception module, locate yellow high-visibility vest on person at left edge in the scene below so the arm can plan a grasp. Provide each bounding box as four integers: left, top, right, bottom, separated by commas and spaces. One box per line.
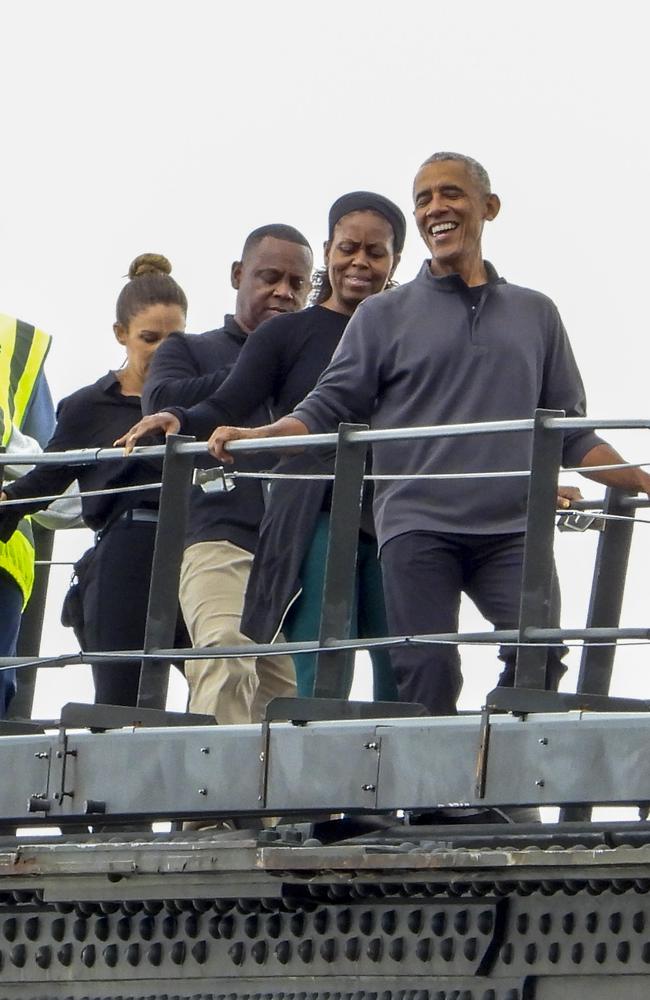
0, 313, 51, 607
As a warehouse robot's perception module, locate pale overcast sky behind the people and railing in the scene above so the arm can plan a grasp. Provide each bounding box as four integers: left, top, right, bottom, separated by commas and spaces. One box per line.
0, 0, 650, 714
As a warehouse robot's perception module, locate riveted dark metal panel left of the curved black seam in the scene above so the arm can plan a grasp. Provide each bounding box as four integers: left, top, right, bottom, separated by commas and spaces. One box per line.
0, 898, 509, 995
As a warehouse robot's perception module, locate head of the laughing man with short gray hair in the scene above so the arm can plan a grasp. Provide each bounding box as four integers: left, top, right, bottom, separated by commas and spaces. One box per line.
413, 160, 499, 274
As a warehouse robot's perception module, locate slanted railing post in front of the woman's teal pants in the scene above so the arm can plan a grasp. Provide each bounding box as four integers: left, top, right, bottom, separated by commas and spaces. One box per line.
314, 424, 368, 698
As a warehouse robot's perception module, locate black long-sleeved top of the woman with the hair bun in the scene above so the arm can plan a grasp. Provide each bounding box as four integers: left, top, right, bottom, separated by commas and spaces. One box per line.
0, 372, 161, 540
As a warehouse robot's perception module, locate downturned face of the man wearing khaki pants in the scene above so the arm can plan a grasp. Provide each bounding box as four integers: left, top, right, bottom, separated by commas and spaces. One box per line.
231, 236, 313, 333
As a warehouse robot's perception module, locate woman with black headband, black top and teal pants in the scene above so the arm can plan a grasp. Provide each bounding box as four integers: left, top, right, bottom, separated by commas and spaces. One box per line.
116, 191, 406, 700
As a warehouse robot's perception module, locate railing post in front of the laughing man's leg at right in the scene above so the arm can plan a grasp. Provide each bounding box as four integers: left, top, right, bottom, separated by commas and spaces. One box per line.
515, 410, 565, 689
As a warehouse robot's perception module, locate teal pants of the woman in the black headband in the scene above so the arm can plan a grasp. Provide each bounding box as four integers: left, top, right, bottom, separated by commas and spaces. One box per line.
282, 513, 397, 701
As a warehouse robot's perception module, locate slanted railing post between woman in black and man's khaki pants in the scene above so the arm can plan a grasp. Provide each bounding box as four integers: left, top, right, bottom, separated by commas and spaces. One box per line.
138, 434, 195, 709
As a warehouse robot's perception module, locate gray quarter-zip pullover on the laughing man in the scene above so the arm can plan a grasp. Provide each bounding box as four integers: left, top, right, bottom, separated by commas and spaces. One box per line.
291, 261, 601, 545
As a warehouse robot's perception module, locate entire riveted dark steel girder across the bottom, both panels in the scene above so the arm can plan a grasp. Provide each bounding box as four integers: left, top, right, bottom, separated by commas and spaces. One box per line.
0, 876, 650, 1000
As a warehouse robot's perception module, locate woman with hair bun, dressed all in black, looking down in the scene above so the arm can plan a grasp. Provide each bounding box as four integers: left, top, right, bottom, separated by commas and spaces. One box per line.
0, 253, 187, 705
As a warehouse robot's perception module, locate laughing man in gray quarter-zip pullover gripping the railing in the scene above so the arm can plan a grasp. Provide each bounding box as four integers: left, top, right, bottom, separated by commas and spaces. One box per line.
210, 153, 650, 715
